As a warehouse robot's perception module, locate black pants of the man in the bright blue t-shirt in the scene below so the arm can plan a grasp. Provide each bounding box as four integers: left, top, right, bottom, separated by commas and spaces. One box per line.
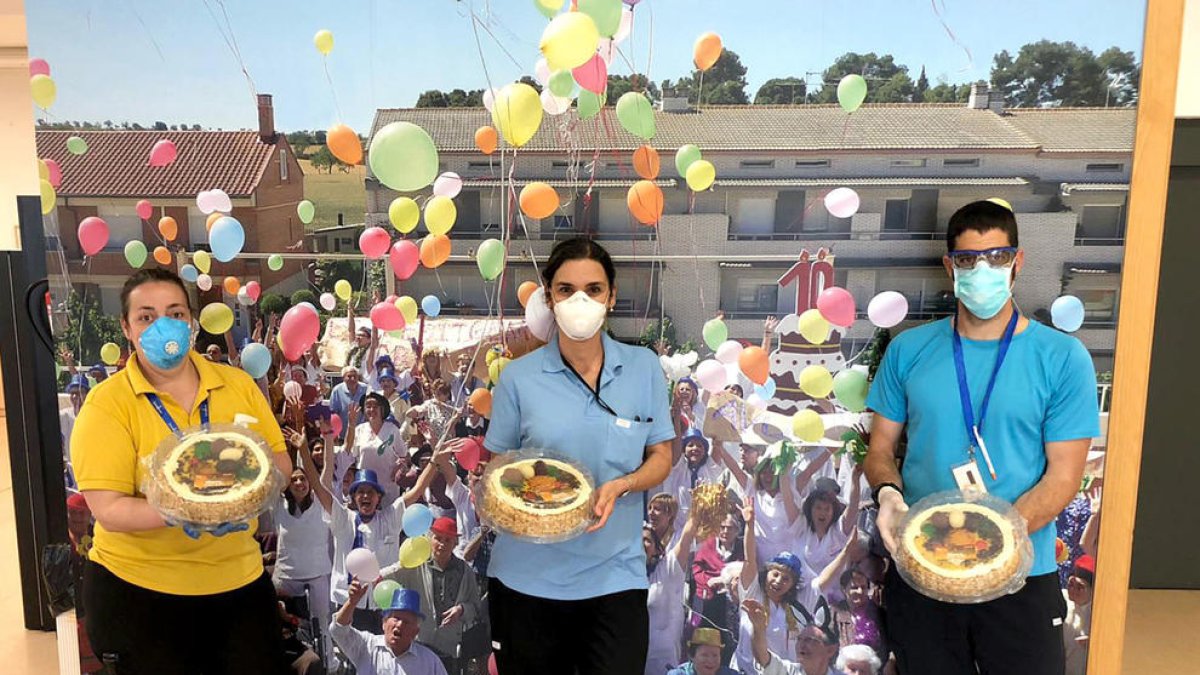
883, 569, 1067, 675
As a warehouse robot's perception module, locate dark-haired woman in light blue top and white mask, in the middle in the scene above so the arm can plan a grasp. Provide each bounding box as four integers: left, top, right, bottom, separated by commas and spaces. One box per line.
484, 238, 674, 675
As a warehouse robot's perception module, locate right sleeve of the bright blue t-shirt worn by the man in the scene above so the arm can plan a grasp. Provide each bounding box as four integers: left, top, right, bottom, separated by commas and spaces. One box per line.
1043, 339, 1100, 443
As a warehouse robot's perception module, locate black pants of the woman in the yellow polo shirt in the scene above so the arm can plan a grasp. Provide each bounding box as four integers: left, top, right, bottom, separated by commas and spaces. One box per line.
83, 562, 288, 675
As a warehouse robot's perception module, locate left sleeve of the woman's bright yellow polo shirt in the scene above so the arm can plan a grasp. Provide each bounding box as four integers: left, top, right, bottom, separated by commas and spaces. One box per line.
71, 401, 138, 495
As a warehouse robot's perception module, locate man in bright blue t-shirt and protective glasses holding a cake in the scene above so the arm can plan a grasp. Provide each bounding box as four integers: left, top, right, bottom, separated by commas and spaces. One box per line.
865, 202, 1099, 675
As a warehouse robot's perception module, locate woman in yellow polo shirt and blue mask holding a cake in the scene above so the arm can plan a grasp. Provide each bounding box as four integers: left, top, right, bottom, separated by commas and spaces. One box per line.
71, 269, 292, 675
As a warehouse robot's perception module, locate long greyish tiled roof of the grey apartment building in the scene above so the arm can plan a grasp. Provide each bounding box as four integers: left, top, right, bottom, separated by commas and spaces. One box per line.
371, 103, 1135, 153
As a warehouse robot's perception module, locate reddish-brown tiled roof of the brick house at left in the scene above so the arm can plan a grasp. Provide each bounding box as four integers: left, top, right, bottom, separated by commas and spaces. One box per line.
37, 130, 275, 198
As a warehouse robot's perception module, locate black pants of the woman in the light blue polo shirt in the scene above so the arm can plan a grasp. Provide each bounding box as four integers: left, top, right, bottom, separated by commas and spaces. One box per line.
487, 578, 650, 675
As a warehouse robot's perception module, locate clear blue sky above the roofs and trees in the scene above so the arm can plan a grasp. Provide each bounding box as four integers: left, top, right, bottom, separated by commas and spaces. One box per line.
26, 0, 1145, 133
